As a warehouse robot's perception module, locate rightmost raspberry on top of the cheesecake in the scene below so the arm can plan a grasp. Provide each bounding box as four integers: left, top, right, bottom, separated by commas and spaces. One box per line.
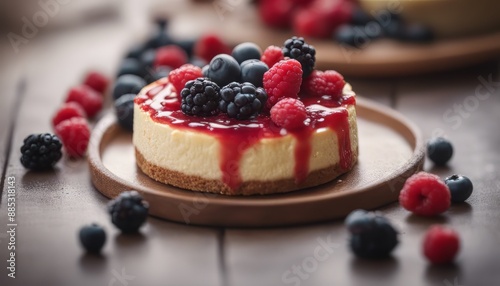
302, 70, 345, 97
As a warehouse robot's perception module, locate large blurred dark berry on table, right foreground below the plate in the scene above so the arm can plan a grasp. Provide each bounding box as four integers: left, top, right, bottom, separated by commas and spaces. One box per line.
345, 210, 399, 259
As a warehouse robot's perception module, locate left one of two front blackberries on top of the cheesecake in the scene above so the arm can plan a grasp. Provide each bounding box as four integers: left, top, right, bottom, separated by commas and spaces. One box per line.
181, 77, 220, 116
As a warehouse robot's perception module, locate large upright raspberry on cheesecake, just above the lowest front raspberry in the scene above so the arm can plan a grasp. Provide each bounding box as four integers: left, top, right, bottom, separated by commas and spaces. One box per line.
263, 60, 302, 109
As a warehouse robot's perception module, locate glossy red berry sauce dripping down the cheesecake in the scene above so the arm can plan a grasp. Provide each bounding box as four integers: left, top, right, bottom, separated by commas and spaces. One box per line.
135, 79, 356, 190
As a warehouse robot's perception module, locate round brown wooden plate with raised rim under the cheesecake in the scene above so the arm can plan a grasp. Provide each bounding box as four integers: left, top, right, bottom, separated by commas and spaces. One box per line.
88, 97, 424, 227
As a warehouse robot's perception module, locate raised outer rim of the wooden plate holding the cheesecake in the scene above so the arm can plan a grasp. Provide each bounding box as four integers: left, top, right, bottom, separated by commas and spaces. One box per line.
88, 97, 424, 227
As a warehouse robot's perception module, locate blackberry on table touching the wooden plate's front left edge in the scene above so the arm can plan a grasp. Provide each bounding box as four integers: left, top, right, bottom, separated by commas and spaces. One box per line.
108, 191, 149, 233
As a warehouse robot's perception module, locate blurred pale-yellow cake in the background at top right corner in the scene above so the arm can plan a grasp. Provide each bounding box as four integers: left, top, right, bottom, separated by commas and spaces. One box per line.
359, 0, 500, 37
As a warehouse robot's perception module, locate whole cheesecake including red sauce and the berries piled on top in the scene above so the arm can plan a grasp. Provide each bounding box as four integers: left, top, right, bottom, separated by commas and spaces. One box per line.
133, 37, 358, 195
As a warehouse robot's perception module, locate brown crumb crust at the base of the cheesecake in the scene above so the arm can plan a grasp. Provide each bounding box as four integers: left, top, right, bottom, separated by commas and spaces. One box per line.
135, 148, 358, 196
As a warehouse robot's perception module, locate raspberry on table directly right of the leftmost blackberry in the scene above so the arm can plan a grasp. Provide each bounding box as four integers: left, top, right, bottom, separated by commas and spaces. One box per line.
55, 117, 90, 157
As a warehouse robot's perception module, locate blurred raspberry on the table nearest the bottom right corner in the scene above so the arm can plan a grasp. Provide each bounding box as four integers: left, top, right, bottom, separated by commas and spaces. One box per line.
423, 225, 460, 264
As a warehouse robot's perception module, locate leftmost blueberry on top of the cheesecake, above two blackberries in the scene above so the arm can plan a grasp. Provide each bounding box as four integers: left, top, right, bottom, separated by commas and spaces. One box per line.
208, 54, 241, 86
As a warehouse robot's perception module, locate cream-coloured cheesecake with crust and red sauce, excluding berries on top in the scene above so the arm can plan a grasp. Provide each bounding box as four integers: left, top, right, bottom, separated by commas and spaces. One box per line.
133, 78, 358, 195
